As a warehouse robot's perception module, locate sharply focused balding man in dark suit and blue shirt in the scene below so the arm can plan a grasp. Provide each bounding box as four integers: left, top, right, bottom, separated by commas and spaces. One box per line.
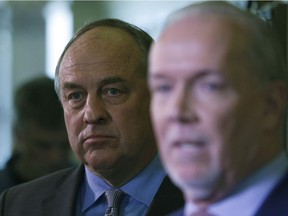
0, 19, 182, 216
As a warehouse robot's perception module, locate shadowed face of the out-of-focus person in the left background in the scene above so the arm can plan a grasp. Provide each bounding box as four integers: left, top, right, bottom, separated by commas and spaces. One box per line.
18, 122, 71, 178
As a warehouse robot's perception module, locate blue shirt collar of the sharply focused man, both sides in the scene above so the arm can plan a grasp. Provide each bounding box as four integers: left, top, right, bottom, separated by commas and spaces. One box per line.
81, 155, 165, 211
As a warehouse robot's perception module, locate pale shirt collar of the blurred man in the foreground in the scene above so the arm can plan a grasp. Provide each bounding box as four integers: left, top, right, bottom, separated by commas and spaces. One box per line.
184, 153, 288, 216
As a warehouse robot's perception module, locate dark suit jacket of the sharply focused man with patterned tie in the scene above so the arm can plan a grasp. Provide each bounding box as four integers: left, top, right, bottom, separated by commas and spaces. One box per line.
0, 165, 184, 216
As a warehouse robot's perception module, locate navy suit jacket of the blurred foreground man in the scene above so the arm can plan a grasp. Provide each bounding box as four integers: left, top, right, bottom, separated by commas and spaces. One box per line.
169, 173, 288, 216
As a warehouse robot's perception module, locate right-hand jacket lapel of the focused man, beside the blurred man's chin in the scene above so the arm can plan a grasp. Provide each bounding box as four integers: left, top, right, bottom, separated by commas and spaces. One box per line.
146, 176, 184, 216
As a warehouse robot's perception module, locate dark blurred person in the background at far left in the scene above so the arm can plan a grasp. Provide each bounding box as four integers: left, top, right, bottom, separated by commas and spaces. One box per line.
0, 76, 75, 193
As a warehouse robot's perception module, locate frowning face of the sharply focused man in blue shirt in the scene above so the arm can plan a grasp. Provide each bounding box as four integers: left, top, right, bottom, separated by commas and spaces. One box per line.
59, 27, 156, 184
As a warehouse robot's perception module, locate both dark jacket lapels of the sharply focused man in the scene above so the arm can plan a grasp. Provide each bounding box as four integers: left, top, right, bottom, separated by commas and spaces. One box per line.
42, 165, 184, 216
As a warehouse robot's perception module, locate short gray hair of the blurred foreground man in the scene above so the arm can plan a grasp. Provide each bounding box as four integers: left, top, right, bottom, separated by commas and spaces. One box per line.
164, 1, 287, 84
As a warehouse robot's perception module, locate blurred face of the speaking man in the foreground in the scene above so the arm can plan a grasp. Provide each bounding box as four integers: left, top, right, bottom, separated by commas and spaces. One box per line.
149, 18, 265, 200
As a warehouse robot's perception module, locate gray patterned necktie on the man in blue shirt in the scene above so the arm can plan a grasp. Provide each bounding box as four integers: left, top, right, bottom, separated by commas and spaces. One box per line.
105, 189, 125, 216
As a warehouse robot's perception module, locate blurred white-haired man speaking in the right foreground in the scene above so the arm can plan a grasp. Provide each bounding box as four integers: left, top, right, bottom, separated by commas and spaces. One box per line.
148, 2, 288, 216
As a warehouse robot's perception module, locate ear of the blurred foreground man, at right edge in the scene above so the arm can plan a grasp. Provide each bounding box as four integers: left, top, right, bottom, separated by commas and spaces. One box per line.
264, 80, 288, 132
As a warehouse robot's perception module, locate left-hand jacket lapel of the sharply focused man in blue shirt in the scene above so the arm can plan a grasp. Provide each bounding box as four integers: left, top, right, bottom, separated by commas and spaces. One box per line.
42, 165, 84, 216
